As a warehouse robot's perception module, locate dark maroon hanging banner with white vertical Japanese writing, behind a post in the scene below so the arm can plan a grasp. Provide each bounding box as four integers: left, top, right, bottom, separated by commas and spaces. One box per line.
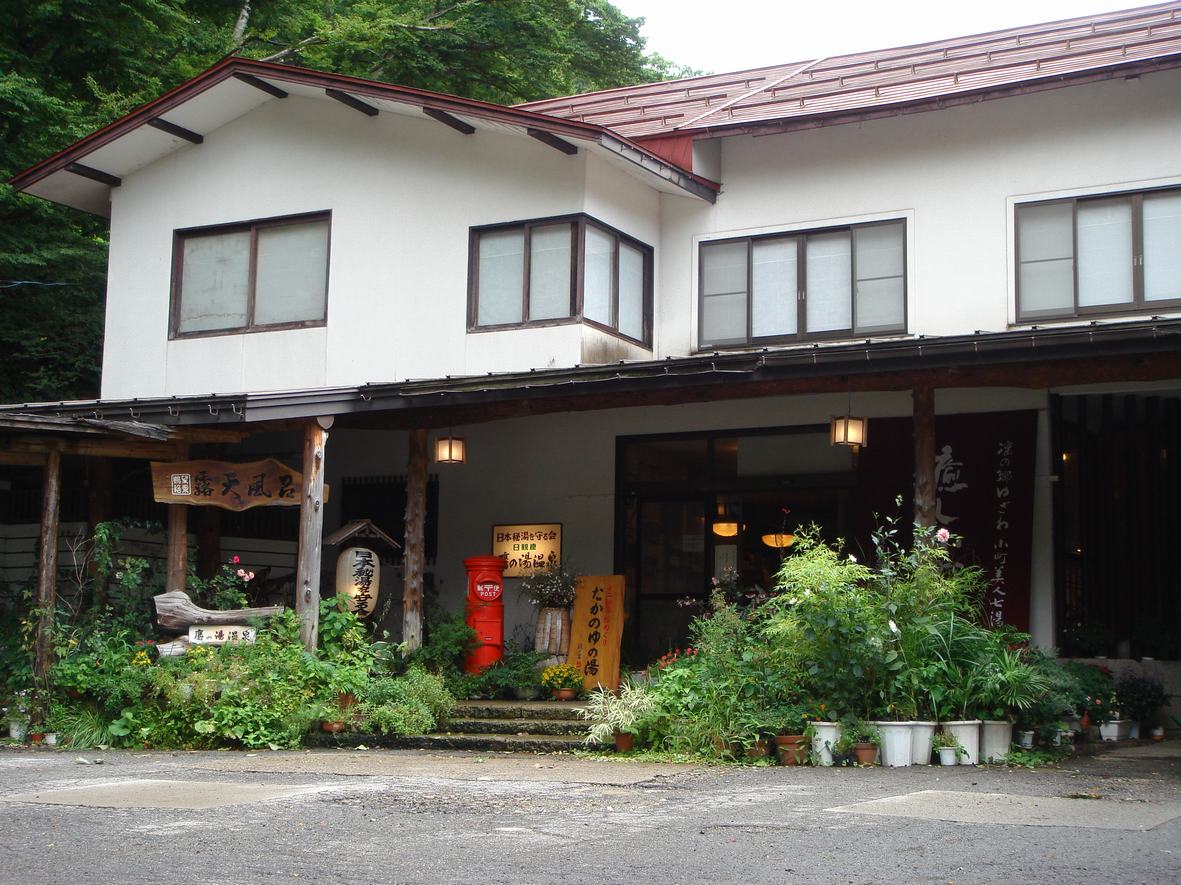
855, 411, 1037, 630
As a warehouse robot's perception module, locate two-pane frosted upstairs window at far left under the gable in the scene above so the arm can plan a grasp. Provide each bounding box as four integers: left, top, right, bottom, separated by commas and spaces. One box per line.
172, 213, 329, 337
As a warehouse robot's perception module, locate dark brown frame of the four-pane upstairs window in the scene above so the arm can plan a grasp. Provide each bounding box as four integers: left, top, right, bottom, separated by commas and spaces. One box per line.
697, 217, 911, 352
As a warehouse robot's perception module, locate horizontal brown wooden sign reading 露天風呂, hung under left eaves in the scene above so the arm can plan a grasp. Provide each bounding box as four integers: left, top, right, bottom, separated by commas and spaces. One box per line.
151, 458, 328, 510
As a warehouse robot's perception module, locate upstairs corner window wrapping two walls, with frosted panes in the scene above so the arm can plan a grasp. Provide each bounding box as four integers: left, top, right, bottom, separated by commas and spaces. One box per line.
469, 215, 652, 345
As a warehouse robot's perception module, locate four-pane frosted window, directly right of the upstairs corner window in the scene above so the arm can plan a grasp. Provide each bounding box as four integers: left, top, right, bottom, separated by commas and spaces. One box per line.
699, 221, 906, 347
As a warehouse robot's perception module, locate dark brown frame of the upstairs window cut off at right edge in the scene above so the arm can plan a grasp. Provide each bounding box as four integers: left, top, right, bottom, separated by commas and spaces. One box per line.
1013, 184, 1181, 324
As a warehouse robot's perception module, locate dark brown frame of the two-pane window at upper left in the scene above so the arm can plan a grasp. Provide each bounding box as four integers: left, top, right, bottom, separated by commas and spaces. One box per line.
168, 209, 332, 340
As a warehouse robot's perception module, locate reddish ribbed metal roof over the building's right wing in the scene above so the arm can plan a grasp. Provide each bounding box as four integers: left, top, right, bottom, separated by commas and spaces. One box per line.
517, 0, 1181, 139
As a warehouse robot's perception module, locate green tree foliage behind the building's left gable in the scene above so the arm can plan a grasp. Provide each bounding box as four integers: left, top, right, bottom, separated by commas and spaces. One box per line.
0, 0, 690, 402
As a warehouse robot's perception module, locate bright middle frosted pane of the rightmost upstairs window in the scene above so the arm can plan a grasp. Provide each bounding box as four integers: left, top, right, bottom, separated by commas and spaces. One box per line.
1077, 197, 1133, 307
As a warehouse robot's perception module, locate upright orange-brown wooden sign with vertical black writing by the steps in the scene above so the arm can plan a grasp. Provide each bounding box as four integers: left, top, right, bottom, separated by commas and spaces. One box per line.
566, 574, 624, 691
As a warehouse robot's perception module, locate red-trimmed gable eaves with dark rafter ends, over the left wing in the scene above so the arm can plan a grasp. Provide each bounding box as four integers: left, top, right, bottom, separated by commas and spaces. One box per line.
11, 58, 720, 215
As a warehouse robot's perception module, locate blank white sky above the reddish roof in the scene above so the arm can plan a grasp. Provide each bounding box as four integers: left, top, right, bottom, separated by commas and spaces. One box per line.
614, 0, 1146, 73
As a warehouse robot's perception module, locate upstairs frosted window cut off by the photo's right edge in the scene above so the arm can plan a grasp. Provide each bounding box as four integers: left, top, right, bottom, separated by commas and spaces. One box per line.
1017, 188, 1181, 320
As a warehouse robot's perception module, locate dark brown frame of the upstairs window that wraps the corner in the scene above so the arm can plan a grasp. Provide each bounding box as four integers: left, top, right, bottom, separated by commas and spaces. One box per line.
468, 213, 655, 350
